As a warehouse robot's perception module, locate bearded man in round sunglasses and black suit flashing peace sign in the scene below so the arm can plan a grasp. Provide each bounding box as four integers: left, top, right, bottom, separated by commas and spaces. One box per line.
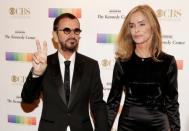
21, 13, 108, 131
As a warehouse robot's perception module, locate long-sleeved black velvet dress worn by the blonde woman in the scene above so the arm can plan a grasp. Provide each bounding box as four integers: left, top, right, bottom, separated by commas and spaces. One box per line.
107, 53, 180, 131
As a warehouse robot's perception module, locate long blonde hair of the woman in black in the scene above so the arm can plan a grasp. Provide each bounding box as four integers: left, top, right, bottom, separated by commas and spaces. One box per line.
115, 5, 162, 61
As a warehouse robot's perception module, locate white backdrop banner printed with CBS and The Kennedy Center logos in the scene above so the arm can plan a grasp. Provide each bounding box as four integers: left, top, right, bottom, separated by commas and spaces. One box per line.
0, 0, 189, 131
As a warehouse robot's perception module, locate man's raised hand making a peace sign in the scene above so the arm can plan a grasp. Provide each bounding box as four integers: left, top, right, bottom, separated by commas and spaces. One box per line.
32, 40, 47, 76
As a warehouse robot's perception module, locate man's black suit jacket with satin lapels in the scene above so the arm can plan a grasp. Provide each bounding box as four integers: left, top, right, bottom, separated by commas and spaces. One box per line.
21, 52, 108, 131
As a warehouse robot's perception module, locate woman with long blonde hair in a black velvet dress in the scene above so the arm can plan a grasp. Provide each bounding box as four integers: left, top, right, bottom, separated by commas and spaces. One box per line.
107, 5, 180, 131
